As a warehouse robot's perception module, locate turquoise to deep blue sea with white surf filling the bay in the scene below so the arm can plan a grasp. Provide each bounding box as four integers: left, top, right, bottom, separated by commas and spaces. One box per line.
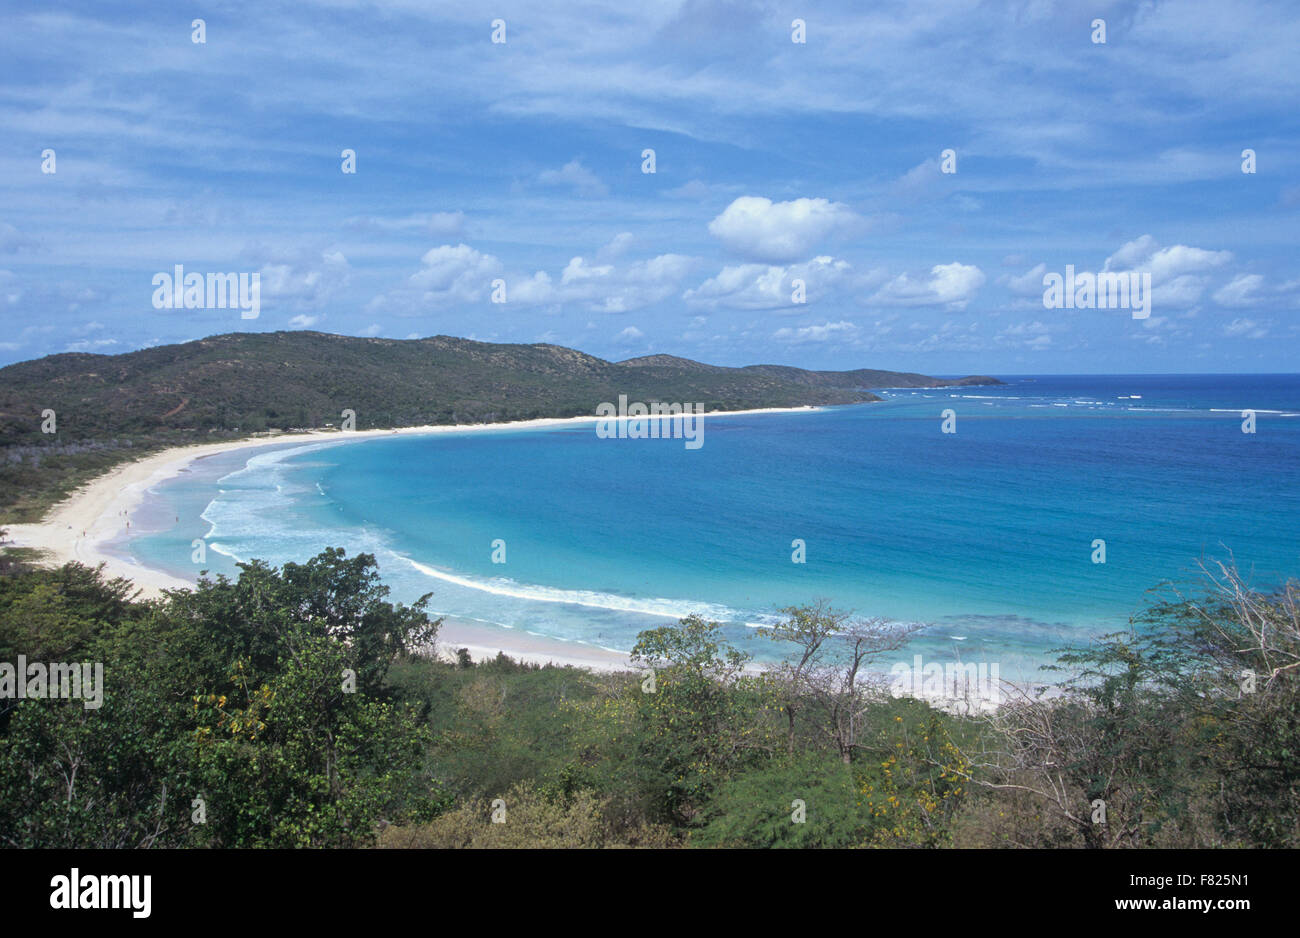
127, 375, 1300, 677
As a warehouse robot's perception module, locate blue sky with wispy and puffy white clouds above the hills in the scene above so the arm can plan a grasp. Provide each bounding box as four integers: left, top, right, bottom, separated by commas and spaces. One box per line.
0, 0, 1300, 374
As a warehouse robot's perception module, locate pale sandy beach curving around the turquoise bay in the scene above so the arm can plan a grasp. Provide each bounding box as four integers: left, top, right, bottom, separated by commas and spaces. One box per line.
7, 405, 820, 670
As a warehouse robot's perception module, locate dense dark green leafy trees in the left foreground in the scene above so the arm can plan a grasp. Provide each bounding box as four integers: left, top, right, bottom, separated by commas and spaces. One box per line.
0, 551, 450, 847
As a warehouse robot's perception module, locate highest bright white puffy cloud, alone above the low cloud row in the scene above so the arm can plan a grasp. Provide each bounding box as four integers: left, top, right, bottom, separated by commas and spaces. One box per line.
709, 195, 861, 264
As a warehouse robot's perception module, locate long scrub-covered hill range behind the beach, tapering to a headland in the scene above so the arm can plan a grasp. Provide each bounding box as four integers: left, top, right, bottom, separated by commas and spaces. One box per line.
0, 331, 1001, 522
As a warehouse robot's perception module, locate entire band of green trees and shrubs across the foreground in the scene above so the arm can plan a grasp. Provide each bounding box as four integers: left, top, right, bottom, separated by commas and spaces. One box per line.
0, 540, 1300, 848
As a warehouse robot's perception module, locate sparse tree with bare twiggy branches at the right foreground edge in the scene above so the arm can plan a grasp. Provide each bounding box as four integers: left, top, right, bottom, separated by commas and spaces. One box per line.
956, 561, 1300, 847
